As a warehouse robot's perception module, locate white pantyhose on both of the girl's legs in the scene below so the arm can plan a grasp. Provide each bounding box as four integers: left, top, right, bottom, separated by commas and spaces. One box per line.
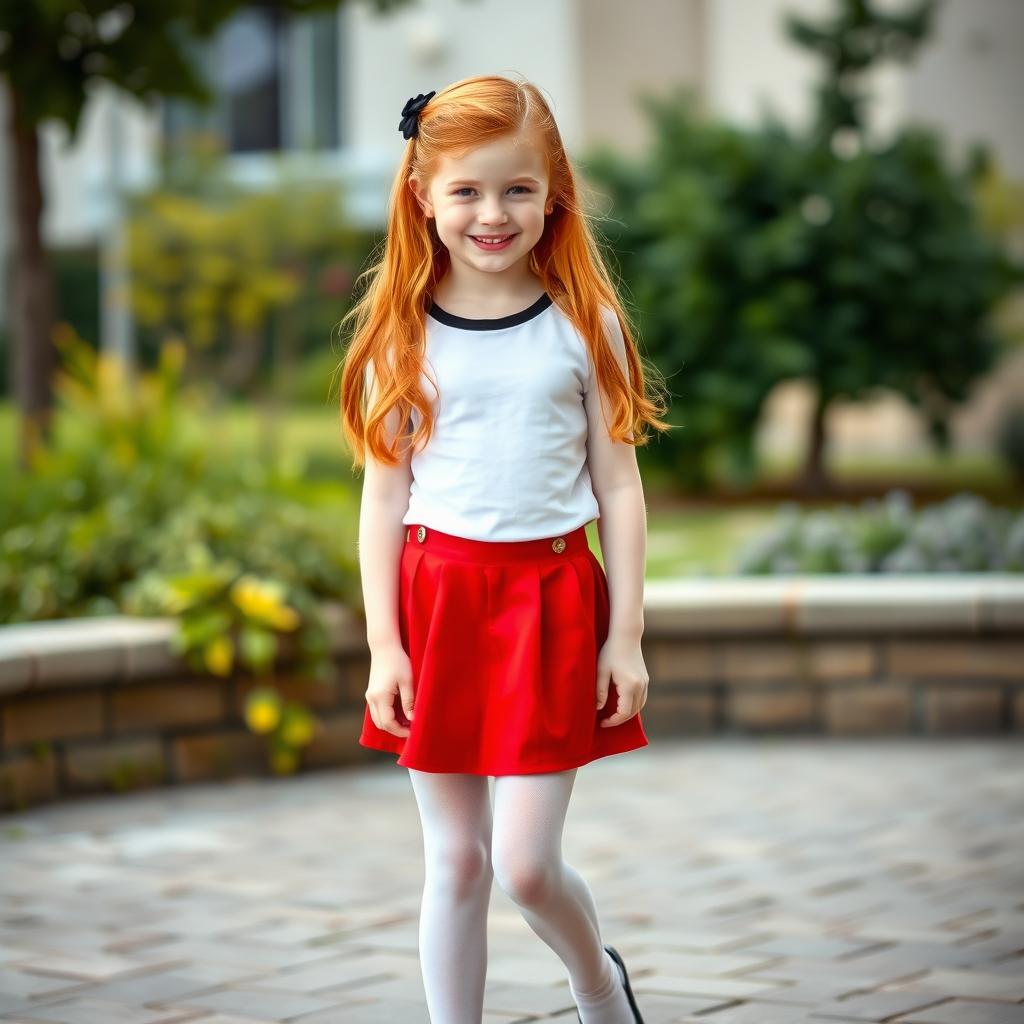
409, 768, 633, 1024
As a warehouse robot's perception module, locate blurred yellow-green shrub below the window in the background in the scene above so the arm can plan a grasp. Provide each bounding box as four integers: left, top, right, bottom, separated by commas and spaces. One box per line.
126, 157, 378, 400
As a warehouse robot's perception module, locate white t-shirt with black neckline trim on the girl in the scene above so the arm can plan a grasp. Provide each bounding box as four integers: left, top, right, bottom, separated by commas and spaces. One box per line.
364, 294, 626, 541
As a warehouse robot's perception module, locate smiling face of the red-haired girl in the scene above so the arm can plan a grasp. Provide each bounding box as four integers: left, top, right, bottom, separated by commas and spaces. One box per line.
410, 135, 553, 282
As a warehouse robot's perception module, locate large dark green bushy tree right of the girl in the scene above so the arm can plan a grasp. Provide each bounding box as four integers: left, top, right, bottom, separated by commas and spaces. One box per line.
589, 0, 1021, 495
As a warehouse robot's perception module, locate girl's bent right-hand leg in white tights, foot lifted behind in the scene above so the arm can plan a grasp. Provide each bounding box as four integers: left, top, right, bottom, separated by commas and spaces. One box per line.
492, 768, 633, 1024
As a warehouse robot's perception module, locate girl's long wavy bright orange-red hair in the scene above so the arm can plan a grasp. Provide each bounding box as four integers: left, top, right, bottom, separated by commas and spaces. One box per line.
337, 75, 670, 468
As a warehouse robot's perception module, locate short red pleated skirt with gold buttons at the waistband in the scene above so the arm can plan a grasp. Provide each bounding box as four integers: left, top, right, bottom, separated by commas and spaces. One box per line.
359, 525, 648, 775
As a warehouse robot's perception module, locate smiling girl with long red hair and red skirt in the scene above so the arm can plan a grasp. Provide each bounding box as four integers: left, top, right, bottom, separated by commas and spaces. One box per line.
341, 76, 667, 1024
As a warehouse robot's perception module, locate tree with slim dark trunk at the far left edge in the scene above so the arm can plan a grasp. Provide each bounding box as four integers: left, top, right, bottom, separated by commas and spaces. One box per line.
0, 0, 409, 466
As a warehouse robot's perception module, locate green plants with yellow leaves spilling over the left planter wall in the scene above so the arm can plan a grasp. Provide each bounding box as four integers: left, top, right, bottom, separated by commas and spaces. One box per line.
0, 327, 361, 766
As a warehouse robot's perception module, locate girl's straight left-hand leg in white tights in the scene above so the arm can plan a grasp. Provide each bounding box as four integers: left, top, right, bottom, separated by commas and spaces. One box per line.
409, 768, 494, 1024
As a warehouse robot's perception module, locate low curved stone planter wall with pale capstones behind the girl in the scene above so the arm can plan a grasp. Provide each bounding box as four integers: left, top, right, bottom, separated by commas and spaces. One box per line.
0, 574, 1024, 809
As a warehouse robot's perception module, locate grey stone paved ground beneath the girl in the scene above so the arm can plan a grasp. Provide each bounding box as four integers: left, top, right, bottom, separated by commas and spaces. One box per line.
0, 737, 1024, 1024
